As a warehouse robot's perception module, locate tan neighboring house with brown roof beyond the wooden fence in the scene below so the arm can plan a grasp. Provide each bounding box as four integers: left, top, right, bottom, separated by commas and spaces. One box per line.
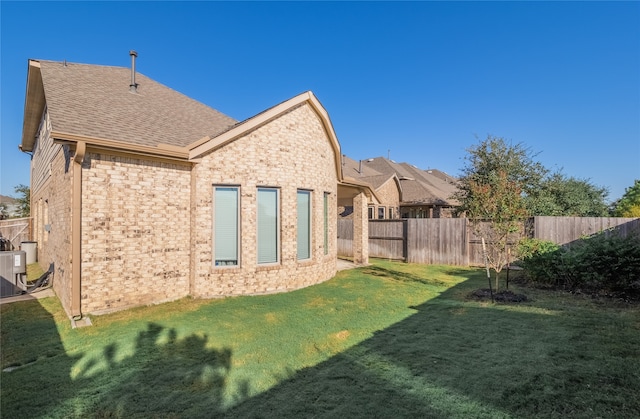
343, 157, 457, 219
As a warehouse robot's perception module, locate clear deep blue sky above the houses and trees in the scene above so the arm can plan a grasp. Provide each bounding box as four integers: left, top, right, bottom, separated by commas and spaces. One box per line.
0, 0, 640, 200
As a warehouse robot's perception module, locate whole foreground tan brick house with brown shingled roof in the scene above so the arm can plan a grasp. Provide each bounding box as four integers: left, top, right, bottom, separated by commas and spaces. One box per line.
20, 53, 373, 318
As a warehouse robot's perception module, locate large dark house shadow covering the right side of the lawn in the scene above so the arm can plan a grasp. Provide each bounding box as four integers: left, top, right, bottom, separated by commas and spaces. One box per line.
225, 267, 640, 418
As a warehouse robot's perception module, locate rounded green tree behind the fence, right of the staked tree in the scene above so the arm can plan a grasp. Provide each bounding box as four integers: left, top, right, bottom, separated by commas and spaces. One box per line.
527, 172, 609, 217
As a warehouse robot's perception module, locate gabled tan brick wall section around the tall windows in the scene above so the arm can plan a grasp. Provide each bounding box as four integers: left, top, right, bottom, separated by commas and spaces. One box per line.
191, 103, 337, 297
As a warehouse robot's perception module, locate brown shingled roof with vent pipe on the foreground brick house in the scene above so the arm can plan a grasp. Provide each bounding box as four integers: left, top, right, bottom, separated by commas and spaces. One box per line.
22, 60, 237, 151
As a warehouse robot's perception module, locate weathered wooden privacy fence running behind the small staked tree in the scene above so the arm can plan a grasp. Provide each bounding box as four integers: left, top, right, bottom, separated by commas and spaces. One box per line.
338, 217, 640, 266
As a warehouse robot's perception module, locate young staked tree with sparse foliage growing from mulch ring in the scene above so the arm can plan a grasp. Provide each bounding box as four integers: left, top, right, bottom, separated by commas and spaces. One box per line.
453, 136, 547, 289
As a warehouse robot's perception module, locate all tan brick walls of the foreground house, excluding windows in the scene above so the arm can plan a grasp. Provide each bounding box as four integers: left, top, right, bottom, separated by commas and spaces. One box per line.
32, 103, 337, 314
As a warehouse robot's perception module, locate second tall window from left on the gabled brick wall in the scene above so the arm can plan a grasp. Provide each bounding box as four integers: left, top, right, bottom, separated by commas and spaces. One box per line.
257, 188, 280, 263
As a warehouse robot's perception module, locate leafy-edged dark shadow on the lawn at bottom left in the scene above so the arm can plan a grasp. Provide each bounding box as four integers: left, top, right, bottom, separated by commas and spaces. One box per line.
0, 301, 234, 418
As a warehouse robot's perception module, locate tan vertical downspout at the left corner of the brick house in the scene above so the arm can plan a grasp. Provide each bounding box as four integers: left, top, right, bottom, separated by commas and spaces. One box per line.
71, 141, 87, 320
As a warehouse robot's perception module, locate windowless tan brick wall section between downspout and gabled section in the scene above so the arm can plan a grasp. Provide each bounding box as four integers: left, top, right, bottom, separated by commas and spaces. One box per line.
81, 151, 191, 313
